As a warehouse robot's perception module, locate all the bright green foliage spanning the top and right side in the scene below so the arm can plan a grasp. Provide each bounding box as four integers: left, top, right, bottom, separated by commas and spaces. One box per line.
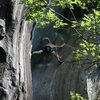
21, 0, 100, 65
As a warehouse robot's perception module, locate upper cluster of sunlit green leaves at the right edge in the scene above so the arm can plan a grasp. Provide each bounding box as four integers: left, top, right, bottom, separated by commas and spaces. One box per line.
81, 10, 100, 36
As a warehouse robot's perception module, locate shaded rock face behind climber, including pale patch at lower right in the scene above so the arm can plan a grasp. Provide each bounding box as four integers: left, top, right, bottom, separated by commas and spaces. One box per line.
31, 9, 100, 100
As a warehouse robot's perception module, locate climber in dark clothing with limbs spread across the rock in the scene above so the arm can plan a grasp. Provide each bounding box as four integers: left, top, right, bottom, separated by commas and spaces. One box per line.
32, 37, 65, 64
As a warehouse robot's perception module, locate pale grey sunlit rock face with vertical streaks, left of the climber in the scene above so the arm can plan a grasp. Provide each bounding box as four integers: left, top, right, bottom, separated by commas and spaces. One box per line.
0, 0, 32, 100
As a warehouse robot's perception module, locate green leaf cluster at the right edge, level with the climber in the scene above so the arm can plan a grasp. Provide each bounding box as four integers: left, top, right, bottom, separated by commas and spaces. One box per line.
75, 40, 100, 62
